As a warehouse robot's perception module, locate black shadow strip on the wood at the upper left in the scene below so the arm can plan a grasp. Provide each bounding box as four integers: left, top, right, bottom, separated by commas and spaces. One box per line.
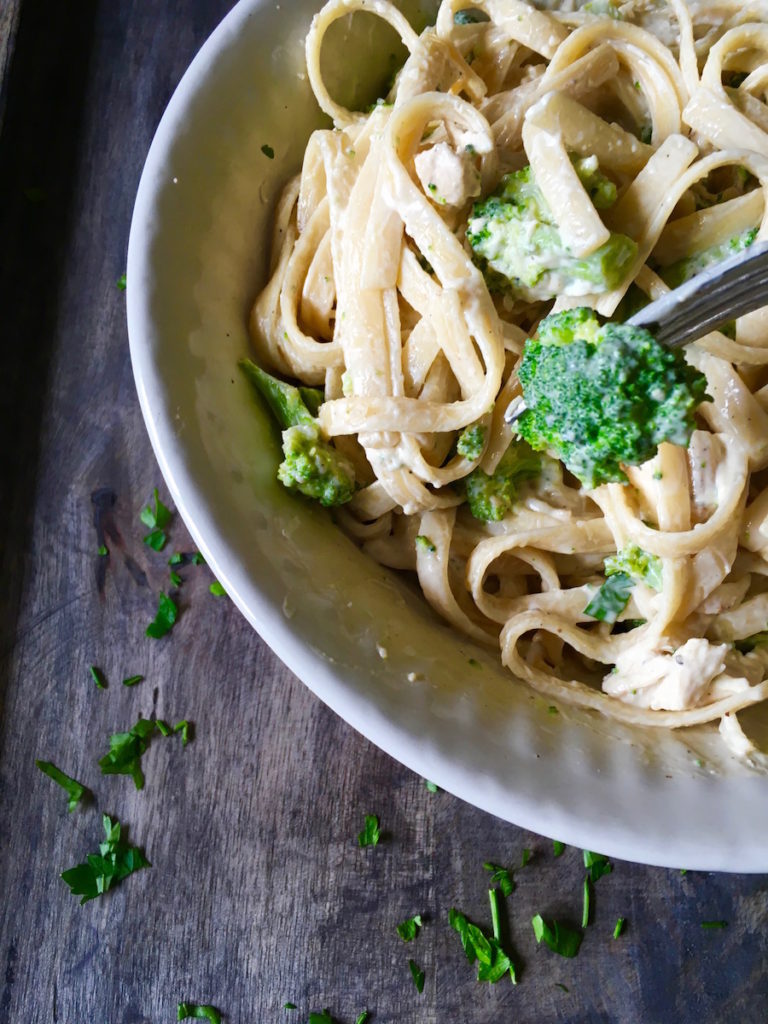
0, 0, 98, 745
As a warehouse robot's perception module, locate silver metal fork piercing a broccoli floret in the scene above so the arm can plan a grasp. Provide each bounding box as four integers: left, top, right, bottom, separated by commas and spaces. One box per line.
504, 241, 768, 423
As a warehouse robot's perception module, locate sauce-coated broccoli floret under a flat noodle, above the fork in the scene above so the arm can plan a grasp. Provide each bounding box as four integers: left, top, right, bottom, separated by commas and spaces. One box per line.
467, 157, 637, 300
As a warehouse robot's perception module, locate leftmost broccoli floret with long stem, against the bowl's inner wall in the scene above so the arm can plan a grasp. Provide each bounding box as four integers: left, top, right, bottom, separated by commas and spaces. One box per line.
240, 359, 354, 506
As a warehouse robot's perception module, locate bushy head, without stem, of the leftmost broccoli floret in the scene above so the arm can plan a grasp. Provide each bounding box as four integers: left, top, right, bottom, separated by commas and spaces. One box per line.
278, 423, 354, 506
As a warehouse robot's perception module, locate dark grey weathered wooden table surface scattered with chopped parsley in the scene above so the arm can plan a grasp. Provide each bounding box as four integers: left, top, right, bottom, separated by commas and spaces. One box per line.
0, 0, 768, 1024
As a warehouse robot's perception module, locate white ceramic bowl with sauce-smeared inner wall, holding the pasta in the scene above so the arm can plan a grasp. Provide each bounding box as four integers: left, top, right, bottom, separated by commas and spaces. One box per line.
127, 0, 768, 871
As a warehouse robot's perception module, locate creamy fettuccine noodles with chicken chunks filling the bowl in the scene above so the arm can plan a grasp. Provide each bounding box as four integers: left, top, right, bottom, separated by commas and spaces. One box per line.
251, 0, 768, 759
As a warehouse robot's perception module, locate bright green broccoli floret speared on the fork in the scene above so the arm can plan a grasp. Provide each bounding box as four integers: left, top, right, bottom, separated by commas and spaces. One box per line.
517, 309, 709, 487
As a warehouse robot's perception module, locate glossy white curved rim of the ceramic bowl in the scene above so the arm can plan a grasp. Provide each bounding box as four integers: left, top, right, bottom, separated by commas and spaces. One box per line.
126, 0, 768, 872
